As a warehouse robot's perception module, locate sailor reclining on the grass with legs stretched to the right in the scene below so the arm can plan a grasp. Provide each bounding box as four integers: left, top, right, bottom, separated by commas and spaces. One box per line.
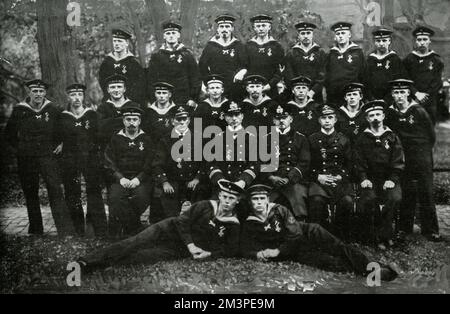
240, 184, 397, 280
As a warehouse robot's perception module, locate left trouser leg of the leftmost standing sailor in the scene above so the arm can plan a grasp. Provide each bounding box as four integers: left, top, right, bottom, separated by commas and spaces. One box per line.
17, 157, 44, 235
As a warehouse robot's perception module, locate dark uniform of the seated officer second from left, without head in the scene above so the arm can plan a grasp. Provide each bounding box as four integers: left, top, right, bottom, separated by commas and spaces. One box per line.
150, 129, 211, 223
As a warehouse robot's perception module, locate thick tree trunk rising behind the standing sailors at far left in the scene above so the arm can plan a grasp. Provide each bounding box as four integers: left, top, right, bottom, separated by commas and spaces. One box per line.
36, 0, 77, 106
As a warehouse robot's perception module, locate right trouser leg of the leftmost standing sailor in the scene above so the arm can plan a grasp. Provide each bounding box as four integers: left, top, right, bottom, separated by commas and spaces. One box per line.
39, 156, 75, 235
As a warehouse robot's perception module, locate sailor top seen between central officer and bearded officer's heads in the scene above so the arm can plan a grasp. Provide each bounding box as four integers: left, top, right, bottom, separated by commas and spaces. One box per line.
241, 96, 277, 128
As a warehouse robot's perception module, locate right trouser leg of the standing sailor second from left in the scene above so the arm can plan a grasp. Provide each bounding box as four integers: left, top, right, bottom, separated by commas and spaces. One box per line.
83, 158, 107, 236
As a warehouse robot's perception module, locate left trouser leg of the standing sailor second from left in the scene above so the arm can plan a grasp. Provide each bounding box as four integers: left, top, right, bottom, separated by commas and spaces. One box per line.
61, 156, 84, 236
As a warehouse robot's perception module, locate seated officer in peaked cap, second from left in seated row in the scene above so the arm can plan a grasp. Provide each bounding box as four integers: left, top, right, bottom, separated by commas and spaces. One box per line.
150, 106, 210, 223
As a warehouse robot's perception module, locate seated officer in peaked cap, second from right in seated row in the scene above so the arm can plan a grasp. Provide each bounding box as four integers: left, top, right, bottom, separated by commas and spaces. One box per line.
309, 105, 353, 238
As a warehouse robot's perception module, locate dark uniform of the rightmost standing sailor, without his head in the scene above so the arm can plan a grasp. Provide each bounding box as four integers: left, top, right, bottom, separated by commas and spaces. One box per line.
390, 103, 439, 235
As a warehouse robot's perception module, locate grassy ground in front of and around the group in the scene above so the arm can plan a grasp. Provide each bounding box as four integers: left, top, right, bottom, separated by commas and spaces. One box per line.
0, 121, 450, 293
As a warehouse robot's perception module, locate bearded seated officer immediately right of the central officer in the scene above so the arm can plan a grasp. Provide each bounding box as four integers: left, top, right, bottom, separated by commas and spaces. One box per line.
261, 105, 311, 219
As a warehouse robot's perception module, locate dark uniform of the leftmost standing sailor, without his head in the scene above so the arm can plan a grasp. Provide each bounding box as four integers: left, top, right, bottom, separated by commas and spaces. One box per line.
5, 99, 74, 235
